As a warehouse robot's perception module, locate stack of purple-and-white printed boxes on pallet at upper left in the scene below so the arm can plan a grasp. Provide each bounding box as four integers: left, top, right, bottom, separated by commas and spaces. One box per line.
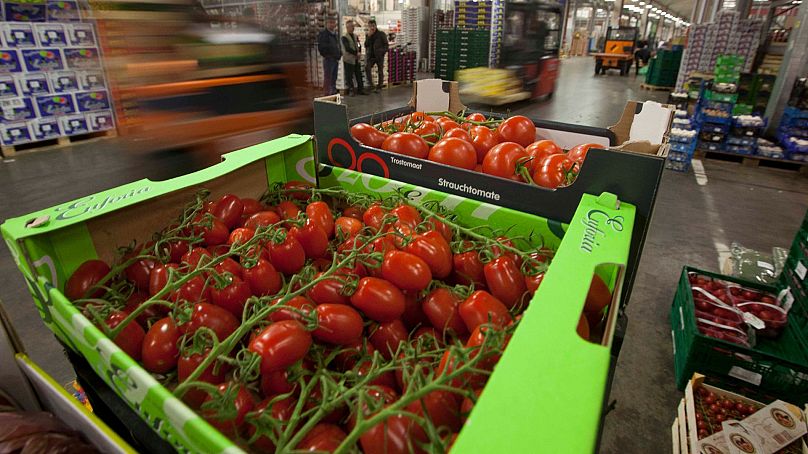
0, 1, 115, 154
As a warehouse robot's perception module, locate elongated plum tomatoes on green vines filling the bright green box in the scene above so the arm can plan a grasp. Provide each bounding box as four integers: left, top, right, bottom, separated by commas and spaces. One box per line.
64, 182, 611, 453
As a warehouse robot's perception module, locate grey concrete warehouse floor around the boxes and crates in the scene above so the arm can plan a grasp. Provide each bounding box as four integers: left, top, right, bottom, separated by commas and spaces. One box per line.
0, 58, 808, 454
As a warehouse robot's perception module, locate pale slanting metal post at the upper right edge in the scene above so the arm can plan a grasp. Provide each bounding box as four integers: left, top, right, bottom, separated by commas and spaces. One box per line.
766, 2, 808, 135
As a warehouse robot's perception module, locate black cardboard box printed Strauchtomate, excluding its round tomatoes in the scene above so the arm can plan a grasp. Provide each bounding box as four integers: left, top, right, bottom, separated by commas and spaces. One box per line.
314, 79, 672, 310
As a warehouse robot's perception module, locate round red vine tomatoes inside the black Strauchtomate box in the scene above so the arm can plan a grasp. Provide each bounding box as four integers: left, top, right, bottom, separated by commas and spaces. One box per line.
351, 112, 600, 189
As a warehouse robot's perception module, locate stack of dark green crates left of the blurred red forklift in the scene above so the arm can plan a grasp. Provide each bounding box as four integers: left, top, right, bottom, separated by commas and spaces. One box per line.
435, 28, 491, 80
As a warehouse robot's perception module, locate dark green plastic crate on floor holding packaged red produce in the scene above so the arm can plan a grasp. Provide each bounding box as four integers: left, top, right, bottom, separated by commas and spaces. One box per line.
670, 266, 808, 402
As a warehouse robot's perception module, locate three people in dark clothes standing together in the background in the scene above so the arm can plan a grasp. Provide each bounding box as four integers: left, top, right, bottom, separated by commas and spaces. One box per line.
317, 18, 389, 96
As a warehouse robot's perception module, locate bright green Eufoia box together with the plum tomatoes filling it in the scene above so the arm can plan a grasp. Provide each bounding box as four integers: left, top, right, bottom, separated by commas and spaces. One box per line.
3, 137, 633, 453
